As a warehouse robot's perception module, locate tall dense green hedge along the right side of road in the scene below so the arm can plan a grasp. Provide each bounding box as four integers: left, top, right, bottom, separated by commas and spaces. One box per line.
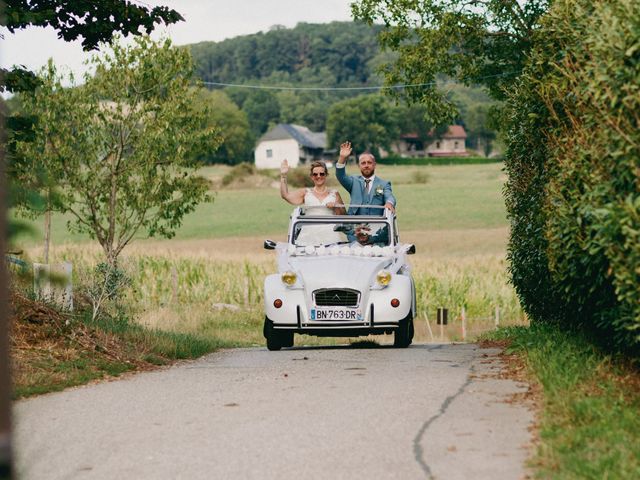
505, 0, 640, 354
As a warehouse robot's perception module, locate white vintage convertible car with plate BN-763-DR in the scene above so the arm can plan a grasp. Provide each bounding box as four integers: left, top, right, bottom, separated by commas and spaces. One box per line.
264, 207, 416, 350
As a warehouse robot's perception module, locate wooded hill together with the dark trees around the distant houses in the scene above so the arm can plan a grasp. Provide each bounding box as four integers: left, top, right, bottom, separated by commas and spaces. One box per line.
189, 22, 495, 163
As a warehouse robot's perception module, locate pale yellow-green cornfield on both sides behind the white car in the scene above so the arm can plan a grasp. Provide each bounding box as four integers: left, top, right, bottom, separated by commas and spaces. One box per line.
32, 245, 527, 345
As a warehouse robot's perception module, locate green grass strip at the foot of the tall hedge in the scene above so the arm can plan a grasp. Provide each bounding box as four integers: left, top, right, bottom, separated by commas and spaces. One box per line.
485, 324, 640, 480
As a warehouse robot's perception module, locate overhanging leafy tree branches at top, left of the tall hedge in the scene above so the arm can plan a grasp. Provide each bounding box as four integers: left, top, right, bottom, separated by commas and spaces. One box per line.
352, 0, 549, 123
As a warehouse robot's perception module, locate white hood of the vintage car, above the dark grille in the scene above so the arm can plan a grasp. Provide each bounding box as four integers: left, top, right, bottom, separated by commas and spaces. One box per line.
288, 256, 392, 292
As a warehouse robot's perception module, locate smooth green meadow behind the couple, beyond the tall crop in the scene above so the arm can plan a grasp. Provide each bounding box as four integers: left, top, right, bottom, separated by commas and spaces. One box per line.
16, 163, 507, 245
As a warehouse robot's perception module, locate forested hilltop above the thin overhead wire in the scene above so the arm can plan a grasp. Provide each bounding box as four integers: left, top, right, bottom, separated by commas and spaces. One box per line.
191, 22, 383, 86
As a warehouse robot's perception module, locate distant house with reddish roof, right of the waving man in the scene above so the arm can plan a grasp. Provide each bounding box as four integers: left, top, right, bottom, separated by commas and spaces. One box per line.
392, 125, 468, 157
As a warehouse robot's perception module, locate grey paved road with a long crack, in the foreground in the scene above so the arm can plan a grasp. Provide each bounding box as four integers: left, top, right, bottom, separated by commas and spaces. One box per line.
14, 344, 533, 480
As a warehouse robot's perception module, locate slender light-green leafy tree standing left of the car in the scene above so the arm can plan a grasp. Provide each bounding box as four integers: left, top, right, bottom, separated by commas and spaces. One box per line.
16, 37, 219, 265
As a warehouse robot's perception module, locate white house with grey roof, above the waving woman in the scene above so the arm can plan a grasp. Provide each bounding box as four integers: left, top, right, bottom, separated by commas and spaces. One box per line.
254, 123, 327, 168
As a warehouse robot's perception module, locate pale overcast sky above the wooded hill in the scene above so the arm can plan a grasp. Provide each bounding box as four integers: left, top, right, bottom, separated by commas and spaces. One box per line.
0, 0, 353, 79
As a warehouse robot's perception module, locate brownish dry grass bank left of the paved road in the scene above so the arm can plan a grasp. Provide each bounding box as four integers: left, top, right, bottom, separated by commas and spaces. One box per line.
10, 293, 224, 399
